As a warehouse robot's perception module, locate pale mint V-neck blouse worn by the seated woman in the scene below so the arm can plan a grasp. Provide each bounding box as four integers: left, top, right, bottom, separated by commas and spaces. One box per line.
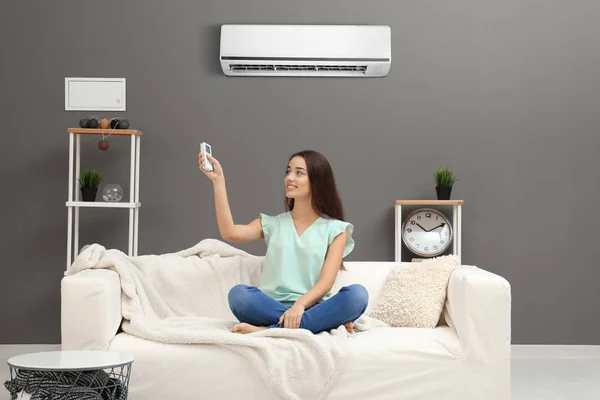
259, 211, 354, 306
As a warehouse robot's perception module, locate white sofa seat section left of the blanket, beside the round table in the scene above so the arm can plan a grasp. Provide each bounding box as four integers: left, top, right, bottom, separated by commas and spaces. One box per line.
109, 332, 280, 400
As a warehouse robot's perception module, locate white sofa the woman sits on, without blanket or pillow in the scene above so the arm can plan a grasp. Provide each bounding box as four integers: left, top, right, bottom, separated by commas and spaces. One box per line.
61, 262, 511, 400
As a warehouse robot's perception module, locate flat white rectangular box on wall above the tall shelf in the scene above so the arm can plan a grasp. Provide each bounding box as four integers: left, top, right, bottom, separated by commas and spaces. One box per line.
65, 78, 126, 111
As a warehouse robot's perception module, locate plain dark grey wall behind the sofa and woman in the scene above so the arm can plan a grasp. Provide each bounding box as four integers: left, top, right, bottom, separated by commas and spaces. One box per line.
0, 0, 600, 344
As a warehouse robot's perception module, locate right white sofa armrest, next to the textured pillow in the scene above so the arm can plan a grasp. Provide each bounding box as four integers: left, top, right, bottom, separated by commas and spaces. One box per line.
444, 265, 511, 399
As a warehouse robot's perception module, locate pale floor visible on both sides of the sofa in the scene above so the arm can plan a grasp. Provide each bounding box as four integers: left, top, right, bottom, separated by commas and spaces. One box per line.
0, 345, 600, 400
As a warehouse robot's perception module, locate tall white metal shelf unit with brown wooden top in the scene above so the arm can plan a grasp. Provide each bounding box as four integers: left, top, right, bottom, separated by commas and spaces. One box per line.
65, 128, 142, 271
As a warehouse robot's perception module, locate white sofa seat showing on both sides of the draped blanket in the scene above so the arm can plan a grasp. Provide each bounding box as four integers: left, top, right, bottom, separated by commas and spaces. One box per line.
110, 326, 464, 400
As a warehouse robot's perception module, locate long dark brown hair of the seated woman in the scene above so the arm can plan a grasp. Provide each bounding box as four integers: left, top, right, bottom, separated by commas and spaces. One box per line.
285, 150, 346, 270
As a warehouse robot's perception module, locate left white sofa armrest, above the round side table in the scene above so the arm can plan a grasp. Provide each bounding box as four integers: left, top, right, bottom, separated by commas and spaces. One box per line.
61, 269, 122, 350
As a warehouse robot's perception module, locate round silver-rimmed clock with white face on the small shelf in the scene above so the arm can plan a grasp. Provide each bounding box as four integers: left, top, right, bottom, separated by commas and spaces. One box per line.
402, 208, 452, 257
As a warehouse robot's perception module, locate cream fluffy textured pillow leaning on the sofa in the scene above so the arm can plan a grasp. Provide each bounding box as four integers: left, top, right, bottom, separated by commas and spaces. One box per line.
369, 255, 458, 328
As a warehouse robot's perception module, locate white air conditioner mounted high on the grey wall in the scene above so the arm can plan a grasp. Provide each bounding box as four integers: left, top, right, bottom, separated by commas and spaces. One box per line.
220, 24, 392, 77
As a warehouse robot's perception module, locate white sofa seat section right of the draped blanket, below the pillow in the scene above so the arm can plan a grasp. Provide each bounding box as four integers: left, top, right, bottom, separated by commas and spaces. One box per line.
332, 326, 464, 400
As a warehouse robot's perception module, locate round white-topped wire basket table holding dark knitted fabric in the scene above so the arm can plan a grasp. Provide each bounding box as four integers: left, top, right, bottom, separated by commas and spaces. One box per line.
4, 350, 134, 400
